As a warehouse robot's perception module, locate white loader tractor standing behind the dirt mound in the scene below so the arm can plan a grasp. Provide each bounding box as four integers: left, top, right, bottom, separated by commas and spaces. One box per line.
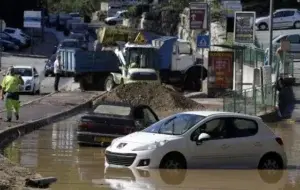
105, 43, 160, 91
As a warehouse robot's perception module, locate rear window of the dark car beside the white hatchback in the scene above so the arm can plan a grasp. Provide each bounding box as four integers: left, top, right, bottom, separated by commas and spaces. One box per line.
94, 105, 131, 116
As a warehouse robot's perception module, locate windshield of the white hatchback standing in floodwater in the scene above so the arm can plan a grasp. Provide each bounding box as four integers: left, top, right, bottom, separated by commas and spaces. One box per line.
143, 113, 205, 135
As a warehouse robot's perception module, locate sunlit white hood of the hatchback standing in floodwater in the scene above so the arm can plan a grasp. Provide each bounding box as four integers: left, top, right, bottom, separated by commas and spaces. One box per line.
111, 132, 182, 151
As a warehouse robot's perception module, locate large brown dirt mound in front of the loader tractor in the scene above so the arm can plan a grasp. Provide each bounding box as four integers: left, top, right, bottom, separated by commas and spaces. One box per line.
99, 83, 204, 111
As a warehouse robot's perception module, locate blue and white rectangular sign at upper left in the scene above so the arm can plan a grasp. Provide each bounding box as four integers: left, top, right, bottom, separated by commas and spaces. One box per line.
23, 11, 42, 28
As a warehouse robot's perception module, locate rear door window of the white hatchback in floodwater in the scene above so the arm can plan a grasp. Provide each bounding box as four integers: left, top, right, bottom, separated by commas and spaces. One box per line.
231, 118, 258, 138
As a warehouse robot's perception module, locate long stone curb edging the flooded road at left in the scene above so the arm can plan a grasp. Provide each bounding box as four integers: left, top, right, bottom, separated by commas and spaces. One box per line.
0, 92, 105, 149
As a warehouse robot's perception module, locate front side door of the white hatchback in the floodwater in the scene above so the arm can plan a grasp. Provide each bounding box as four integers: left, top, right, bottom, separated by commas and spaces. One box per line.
188, 117, 230, 169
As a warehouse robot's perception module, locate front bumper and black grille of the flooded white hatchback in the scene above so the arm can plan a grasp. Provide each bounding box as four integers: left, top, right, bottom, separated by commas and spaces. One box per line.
105, 147, 161, 169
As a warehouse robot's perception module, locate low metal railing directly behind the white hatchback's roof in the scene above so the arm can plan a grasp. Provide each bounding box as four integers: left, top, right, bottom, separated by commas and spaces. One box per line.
223, 84, 276, 115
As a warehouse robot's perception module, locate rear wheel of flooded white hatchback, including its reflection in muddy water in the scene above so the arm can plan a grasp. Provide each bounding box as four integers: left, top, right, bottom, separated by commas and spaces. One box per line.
258, 153, 284, 184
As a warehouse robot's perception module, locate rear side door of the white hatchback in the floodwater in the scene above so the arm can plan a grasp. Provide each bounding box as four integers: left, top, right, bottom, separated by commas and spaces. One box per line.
220, 117, 262, 169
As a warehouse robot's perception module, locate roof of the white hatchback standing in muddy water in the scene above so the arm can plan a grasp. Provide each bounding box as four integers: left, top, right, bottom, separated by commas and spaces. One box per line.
183, 111, 259, 119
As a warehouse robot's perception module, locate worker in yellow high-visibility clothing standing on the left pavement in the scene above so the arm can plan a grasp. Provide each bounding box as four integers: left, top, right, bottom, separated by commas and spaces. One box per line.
1, 67, 24, 122
